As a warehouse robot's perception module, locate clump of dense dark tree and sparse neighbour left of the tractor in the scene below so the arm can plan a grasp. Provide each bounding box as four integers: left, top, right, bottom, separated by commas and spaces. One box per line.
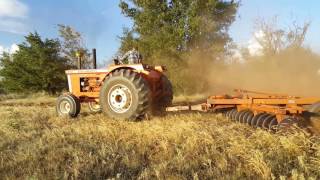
0, 25, 90, 94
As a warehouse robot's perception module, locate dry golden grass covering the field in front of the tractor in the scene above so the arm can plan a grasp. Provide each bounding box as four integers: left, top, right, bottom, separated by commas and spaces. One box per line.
0, 95, 320, 179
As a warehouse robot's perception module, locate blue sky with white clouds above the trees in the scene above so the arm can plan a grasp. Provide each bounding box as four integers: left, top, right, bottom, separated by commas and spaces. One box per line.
0, 0, 320, 62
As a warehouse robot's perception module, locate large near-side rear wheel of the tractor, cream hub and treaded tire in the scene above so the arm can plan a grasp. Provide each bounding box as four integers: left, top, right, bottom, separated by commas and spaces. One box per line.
99, 69, 150, 120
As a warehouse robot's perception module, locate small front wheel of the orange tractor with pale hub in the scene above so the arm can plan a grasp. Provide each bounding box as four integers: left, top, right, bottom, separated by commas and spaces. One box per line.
56, 94, 81, 118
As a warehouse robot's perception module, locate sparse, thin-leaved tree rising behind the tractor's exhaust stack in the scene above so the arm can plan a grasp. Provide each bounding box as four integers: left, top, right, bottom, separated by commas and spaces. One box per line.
58, 24, 92, 68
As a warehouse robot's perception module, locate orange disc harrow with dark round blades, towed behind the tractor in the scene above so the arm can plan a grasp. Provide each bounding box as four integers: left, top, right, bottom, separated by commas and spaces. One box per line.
202, 90, 320, 131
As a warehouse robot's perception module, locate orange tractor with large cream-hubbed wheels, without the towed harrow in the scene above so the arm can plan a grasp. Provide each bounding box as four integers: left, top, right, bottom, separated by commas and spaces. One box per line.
56, 50, 173, 120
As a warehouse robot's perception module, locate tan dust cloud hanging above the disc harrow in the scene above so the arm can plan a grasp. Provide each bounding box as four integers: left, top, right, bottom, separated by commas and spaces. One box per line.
189, 49, 320, 97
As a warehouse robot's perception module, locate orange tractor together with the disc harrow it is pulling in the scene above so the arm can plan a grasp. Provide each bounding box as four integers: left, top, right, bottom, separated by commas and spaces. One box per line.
56, 48, 320, 130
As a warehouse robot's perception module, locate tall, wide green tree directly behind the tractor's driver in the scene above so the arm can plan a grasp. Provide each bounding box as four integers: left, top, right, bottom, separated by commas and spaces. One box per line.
119, 0, 238, 93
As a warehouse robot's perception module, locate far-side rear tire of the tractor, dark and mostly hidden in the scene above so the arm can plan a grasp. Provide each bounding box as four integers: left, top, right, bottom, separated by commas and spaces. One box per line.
152, 75, 173, 115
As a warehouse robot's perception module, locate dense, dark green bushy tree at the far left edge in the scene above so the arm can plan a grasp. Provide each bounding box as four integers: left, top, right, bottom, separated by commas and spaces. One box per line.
0, 33, 68, 93
